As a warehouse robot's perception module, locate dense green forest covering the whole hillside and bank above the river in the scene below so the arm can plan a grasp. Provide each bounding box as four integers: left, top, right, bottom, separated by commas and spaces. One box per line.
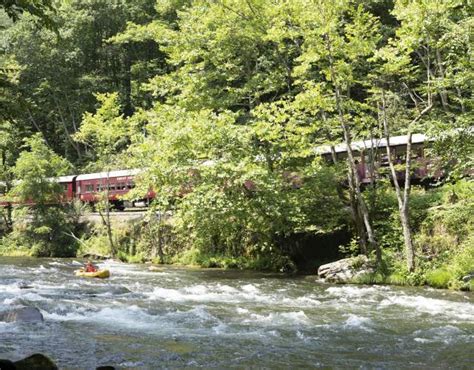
0, 0, 474, 290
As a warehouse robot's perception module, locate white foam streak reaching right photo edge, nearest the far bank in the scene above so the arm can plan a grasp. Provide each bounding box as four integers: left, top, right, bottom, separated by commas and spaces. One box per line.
379, 295, 474, 322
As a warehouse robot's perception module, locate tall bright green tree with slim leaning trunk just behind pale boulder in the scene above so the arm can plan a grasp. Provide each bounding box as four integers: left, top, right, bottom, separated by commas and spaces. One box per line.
280, 1, 381, 262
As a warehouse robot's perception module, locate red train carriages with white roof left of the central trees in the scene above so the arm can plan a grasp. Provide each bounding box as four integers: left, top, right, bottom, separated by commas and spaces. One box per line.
0, 169, 155, 210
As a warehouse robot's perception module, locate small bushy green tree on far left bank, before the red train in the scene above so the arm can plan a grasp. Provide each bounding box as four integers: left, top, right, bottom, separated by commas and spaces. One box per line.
10, 134, 77, 257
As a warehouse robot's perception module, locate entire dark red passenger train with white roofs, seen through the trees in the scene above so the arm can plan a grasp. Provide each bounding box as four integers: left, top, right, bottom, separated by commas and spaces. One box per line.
0, 134, 452, 210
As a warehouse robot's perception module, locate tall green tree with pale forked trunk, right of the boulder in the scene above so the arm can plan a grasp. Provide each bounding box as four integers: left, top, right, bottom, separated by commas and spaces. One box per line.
373, 1, 472, 271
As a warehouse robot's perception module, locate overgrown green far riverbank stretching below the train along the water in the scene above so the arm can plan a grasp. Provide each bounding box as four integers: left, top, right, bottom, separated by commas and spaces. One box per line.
0, 181, 474, 291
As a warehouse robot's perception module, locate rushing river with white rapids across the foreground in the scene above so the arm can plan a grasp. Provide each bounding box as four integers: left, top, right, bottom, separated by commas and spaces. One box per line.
0, 258, 474, 369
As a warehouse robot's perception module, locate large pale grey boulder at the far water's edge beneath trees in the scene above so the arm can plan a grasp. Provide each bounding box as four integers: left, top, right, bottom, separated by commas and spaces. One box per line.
318, 255, 374, 283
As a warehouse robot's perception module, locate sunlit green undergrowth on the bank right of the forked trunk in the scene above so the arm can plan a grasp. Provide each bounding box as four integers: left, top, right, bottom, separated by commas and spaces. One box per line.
379, 181, 474, 290
